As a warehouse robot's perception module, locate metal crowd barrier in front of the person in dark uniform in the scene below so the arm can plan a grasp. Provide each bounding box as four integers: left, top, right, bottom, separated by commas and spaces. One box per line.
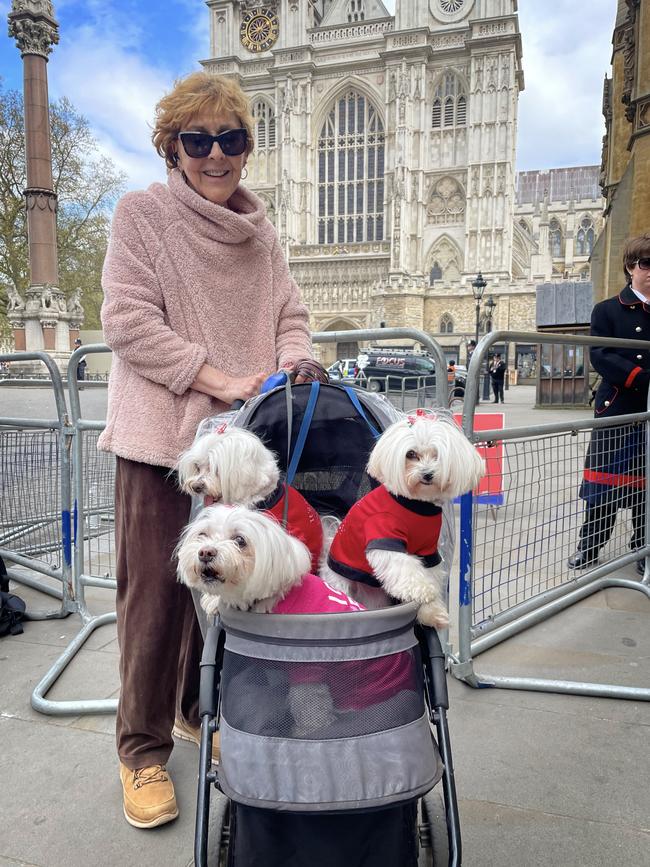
451, 331, 650, 701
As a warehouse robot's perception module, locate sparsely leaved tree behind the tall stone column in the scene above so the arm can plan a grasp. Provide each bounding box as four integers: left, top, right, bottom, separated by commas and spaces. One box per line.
0, 82, 126, 331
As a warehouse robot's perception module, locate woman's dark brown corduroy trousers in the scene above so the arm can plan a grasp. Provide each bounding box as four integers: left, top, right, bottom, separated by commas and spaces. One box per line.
115, 457, 203, 770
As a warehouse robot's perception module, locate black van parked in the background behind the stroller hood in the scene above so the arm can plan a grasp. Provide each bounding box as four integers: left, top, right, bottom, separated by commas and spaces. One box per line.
357, 347, 436, 392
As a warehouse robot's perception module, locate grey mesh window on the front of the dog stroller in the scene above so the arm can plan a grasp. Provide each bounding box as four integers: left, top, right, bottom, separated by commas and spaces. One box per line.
221, 647, 424, 740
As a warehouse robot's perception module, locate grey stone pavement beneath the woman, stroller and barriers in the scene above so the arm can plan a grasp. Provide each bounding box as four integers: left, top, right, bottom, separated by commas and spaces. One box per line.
0, 387, 650, 867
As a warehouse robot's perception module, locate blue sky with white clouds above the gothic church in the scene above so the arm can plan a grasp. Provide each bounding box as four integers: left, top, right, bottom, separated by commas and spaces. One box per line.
0, 0, 616, 188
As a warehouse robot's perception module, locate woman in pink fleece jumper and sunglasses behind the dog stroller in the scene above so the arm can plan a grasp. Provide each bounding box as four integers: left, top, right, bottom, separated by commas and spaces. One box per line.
99, 72, 322, 828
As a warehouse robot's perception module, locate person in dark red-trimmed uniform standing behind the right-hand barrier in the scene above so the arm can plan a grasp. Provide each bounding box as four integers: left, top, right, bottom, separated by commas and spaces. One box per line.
568, 234, 650, 575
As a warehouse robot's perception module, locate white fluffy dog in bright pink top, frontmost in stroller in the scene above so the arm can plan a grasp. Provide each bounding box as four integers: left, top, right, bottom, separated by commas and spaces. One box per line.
176, 505, 367, 736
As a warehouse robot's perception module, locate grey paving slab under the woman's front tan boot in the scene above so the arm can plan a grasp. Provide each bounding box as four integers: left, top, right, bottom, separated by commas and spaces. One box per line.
0, 718, 198, 867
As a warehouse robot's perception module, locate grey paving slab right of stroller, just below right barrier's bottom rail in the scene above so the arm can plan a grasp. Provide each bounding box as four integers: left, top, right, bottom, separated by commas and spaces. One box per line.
449, 691, 650, 831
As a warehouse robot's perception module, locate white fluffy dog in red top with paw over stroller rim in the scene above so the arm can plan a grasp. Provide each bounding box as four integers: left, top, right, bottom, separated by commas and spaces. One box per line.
321, 410, 485, 628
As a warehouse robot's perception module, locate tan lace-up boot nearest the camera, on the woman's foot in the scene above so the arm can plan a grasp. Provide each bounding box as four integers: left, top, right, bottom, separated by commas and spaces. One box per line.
120, 762, 178, 828
